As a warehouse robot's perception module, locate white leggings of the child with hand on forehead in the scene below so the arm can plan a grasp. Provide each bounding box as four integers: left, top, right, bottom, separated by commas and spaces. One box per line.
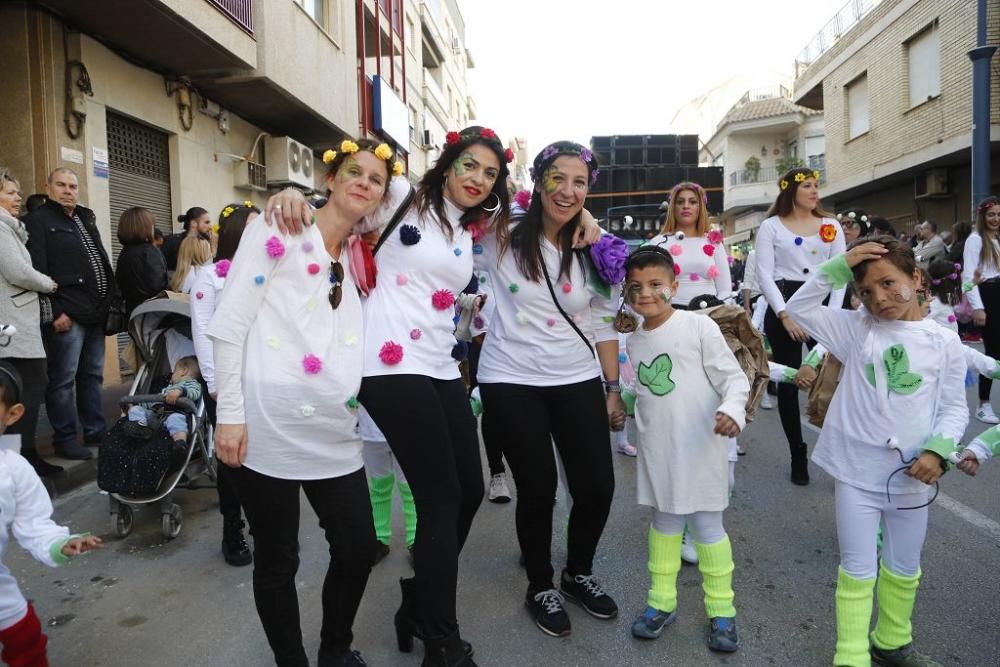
835, 480, 928, 579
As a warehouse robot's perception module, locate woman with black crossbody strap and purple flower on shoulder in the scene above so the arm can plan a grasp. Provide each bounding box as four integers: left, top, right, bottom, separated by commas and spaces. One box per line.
476, 141, 627, 637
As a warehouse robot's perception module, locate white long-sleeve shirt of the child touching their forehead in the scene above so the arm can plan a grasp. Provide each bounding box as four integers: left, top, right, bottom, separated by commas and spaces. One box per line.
788, 257, 969, 494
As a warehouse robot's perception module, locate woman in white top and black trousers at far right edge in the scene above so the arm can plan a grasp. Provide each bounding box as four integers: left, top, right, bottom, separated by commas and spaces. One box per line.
962, 197, 1000, 424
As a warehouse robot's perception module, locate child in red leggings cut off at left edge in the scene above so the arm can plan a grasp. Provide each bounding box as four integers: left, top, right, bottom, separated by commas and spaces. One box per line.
0, 361, 102, 666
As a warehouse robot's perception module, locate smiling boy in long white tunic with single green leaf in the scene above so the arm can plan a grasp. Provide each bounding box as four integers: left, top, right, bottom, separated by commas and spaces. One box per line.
625, 246, 750, 652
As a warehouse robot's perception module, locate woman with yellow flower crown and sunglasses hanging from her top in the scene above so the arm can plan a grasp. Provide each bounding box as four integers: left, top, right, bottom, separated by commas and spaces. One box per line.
208, 140, 393, 667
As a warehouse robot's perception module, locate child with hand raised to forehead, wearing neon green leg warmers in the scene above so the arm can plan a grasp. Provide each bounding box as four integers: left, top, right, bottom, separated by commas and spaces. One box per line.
787, 236, 969, 666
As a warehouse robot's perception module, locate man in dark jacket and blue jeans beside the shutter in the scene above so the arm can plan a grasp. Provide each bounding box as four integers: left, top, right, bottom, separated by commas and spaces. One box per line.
24, 167, 117, 459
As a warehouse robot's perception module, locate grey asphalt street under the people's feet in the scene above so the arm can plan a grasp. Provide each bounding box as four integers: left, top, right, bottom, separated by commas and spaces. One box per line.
8, 392, 1000, 667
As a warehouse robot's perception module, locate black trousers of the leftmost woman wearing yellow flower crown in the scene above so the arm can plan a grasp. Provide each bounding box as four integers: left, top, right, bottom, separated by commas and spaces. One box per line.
231, 467, 375, 667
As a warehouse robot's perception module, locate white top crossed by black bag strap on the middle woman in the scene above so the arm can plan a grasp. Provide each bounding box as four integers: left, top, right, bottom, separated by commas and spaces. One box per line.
475, 234, 621, 387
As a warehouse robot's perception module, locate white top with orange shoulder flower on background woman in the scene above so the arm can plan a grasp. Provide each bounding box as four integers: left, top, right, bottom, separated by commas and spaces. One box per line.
754, 215, 847, 315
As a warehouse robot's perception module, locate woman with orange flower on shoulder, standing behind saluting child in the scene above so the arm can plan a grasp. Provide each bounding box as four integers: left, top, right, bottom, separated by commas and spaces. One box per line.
755, 167, 846, 486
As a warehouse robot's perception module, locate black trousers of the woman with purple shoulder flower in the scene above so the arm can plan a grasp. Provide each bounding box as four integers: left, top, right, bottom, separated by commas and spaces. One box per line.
480, 378, 615, 592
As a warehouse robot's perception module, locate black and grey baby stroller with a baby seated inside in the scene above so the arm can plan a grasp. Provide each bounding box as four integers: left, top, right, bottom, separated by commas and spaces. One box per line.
98, 292, 216, 539
